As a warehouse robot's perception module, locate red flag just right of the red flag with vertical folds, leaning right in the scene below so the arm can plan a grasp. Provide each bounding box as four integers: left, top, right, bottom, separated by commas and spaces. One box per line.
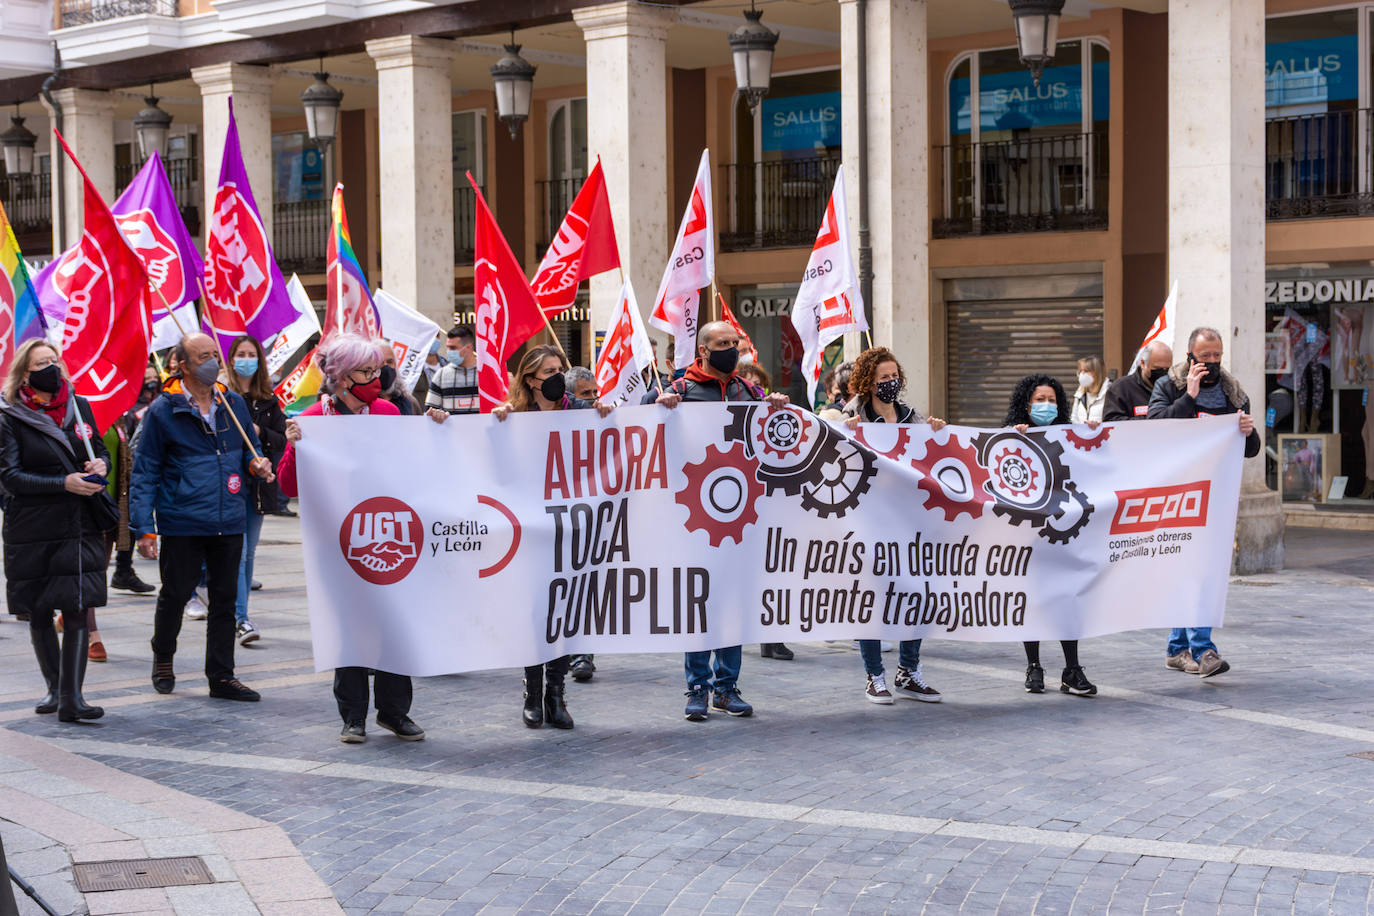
530, 159, 620, 317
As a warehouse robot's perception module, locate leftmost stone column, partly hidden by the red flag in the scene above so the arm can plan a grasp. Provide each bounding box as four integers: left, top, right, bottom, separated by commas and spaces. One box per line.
43, 89, 114, 257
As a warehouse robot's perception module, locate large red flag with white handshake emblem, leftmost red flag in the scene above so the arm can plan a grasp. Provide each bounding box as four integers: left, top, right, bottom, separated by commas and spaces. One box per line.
54, 130, 153, 430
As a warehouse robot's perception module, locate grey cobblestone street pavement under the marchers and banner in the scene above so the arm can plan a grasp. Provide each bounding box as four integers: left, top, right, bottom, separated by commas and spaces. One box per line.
0, 518, 1374, 913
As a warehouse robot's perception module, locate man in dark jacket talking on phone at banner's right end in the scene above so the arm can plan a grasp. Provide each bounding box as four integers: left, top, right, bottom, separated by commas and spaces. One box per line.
1147, 328, 1260, 677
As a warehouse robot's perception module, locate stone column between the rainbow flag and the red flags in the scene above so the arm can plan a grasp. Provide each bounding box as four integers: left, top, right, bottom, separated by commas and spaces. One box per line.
367, 34, 456, 328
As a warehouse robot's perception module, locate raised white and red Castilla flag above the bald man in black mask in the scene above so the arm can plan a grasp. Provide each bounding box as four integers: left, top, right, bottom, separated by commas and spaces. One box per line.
649, 150, 716, 369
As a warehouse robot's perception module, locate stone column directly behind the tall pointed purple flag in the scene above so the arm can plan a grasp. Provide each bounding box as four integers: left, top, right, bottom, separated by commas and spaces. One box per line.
191, 63, 276, 239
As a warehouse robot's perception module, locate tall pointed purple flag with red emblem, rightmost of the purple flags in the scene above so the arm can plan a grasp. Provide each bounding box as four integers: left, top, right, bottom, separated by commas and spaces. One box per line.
203, 99, 297, 357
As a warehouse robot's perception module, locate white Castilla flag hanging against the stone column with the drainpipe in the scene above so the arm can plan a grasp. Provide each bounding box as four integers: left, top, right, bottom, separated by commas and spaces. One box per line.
791, 169, 868, 404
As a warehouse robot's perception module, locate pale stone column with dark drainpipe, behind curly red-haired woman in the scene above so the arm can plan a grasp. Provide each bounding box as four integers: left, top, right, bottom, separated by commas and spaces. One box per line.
840, 0, 933, 411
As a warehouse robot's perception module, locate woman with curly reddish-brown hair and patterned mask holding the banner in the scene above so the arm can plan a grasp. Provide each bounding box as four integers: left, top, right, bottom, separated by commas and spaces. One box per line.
844, 346, 945, 706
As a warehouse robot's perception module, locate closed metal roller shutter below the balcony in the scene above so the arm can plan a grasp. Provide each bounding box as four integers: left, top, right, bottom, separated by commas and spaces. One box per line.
945, 279, 1102, 426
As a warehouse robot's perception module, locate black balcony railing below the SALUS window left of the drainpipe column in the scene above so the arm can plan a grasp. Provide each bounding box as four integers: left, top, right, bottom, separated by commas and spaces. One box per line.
720, 157, 841, 251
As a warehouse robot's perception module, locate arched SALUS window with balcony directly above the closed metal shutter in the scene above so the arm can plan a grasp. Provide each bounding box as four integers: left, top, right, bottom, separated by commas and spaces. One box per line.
932, 40, 1112, 238
